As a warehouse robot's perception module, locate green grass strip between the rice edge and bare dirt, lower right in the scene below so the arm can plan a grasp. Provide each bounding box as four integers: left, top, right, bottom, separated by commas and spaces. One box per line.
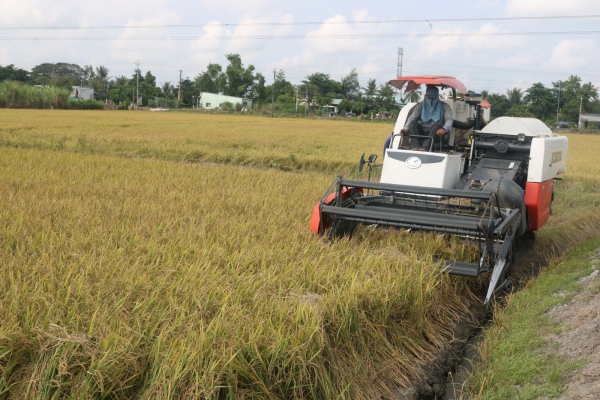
470, 238, 600, 399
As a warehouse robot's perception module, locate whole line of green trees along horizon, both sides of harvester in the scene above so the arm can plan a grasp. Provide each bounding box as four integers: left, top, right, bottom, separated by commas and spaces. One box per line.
0, 54, 600, 125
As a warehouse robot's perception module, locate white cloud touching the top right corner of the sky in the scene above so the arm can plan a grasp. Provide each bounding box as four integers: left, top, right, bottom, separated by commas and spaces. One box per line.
506, 0, 598, 16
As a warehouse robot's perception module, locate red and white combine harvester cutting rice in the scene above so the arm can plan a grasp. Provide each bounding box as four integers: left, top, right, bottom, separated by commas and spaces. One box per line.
310, 76, 568, 303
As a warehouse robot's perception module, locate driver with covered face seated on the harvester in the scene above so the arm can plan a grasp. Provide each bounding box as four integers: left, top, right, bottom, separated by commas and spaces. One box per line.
401, 85, 454, 151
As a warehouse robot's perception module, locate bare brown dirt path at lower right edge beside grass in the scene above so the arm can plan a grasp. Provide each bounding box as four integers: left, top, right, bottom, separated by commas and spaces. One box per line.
548, 248, 600, 400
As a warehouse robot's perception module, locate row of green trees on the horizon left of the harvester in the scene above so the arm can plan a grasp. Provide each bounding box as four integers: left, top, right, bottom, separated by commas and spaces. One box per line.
0, 54, 398, 114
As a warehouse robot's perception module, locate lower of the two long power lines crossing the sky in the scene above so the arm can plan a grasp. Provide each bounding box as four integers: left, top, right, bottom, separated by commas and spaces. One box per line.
0, 31, 600, 41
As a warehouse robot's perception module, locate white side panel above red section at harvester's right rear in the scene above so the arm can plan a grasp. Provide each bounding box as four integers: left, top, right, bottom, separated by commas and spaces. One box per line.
527, 136, 569, 183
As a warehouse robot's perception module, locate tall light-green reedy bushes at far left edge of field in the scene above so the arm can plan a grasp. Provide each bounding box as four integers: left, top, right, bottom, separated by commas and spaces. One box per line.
0, 81, 69, 109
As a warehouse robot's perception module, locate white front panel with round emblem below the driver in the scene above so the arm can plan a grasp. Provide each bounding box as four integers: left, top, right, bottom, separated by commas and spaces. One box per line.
380, 149, 462, 189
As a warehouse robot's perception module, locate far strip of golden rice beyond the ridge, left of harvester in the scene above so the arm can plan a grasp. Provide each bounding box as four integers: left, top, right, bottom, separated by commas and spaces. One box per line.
0, 110, 393, 172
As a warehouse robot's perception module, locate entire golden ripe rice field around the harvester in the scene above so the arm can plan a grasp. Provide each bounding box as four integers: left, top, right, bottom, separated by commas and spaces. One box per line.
0, 110, 600, 399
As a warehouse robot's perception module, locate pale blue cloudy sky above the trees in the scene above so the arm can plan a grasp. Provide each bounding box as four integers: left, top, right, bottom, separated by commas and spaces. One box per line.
0, 0, 600, 93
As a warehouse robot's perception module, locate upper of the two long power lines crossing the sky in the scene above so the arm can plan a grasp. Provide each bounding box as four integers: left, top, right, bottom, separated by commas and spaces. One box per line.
0, 14, 600, 31
